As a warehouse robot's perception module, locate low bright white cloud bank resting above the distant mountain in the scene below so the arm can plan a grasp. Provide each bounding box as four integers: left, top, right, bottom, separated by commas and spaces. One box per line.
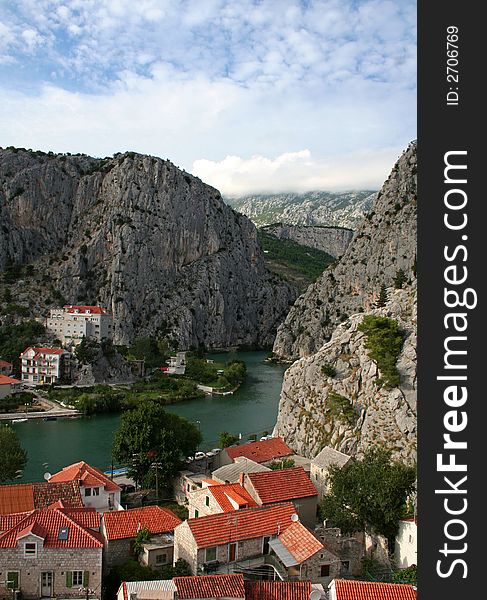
192, 148, 398, 196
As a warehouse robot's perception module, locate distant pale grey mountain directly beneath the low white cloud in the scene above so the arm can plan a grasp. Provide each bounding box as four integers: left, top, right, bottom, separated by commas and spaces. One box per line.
225, 190, 377, 229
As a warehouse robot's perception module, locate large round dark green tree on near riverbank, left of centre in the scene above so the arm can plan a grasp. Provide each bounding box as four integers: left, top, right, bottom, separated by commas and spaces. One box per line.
113, 400, 202, 485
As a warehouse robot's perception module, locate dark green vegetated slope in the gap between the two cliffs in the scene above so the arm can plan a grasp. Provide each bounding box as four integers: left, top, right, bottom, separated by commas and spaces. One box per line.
257, 229, 335, 289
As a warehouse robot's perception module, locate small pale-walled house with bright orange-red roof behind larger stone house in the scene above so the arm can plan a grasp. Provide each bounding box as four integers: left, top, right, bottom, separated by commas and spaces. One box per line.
188, 480, 257, 519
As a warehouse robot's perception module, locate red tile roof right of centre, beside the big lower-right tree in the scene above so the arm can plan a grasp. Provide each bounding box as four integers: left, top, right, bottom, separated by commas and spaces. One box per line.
250, 467, 318, 504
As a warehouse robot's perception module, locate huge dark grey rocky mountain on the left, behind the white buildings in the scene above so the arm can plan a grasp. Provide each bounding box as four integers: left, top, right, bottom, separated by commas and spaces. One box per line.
0, 148, 295, 349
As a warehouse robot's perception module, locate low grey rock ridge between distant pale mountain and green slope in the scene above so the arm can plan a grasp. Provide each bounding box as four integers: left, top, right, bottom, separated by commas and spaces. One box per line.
262, 223, 353, 258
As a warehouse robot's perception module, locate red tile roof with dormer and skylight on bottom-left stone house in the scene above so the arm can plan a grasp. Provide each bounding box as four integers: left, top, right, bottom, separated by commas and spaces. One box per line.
0, 509, 103, 550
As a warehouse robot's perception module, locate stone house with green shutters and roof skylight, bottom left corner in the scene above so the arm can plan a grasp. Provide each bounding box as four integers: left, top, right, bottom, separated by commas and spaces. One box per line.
0, 508, 103, 599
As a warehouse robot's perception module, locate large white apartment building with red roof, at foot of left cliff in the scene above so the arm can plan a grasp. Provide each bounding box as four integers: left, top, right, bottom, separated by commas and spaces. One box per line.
46, 305, 113, 346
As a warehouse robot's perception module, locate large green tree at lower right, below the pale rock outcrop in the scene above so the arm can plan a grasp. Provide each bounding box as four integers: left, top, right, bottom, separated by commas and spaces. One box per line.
320, 448, 416, 544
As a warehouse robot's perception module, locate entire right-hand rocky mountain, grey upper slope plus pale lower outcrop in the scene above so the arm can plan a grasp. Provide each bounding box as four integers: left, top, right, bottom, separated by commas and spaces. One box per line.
274, 143, 417, 462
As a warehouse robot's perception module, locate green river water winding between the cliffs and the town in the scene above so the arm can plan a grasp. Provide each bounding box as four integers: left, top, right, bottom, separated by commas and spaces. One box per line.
13, 352, 284, 482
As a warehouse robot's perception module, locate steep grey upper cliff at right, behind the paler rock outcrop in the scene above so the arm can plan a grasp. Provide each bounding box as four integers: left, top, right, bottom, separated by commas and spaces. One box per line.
273, 143, 417, 360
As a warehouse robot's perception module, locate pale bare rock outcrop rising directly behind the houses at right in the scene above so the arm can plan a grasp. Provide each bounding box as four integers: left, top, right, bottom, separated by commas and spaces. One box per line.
274, 286, 417, 462
